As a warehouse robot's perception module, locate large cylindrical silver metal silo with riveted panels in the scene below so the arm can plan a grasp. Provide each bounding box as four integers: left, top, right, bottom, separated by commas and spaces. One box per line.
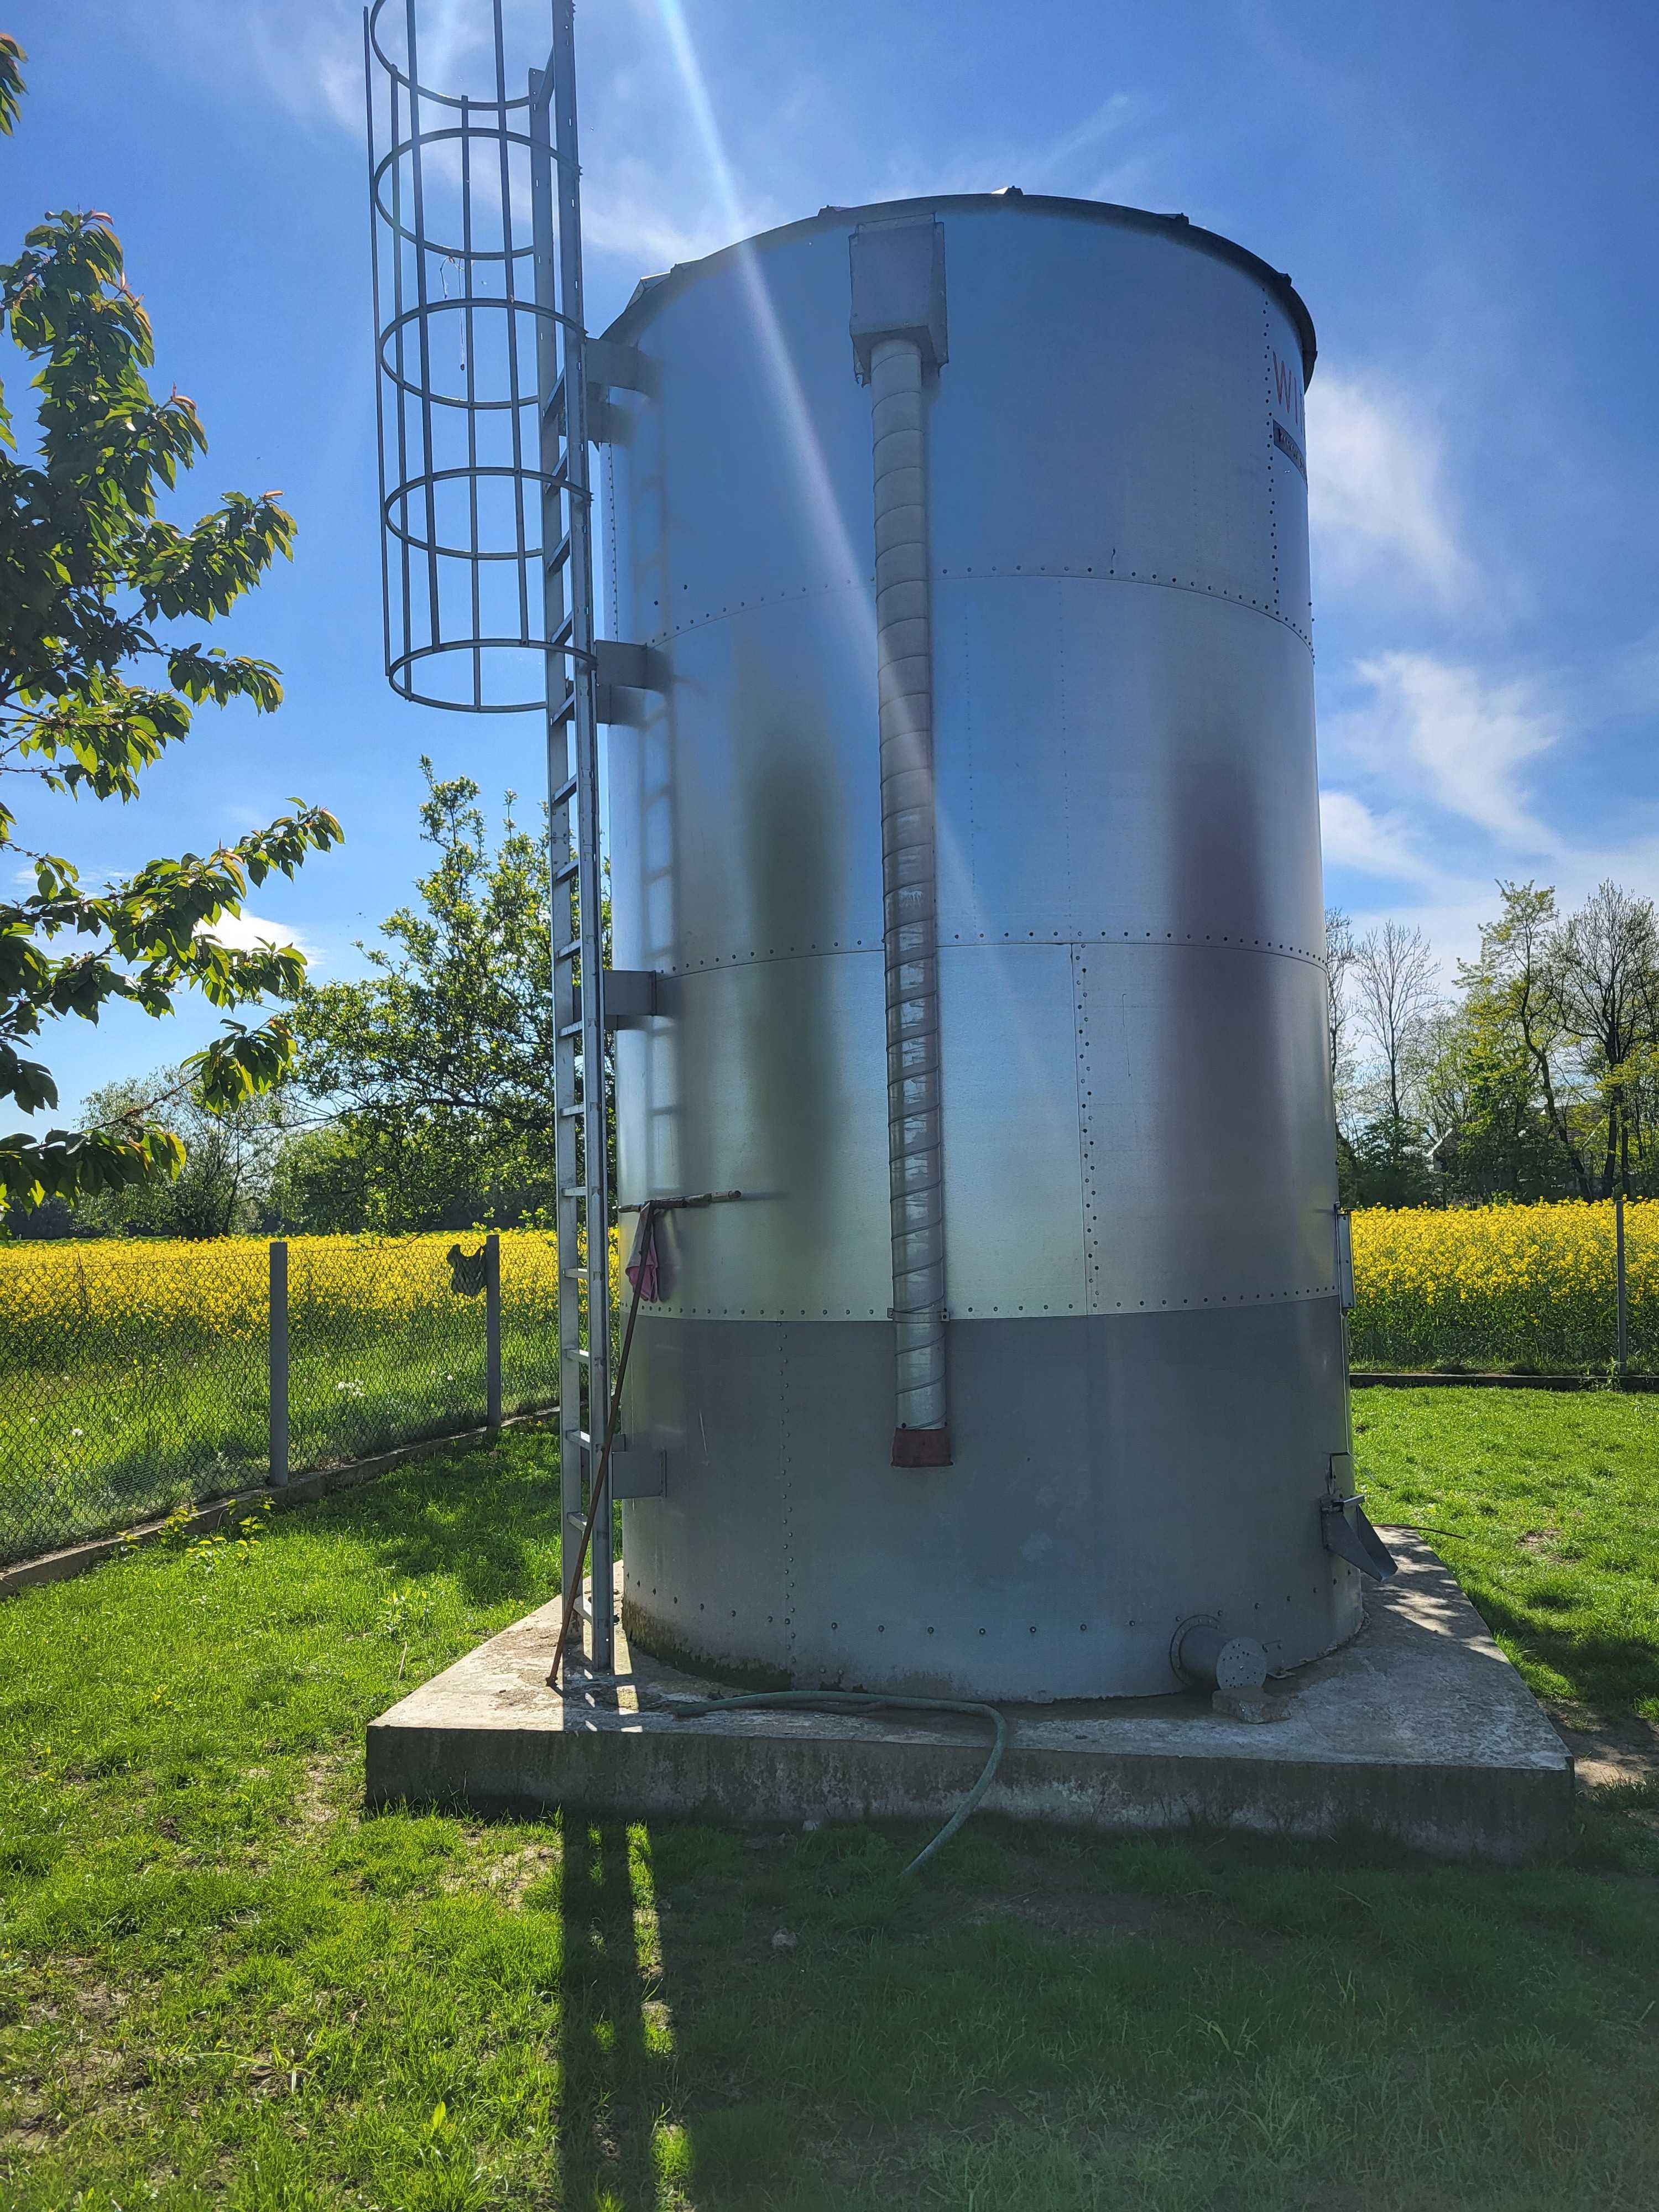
599, 195, 1360, 1699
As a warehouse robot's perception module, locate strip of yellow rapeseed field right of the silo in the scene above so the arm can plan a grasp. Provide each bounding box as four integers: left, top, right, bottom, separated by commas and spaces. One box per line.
1352, 1199, 1659, 1374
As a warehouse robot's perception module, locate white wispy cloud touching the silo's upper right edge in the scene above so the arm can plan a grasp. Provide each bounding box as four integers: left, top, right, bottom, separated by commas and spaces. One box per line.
1307, 367, 1475, 608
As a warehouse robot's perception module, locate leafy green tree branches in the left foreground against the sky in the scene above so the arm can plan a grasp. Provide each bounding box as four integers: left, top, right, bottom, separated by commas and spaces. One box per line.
0, 35, 341, 1203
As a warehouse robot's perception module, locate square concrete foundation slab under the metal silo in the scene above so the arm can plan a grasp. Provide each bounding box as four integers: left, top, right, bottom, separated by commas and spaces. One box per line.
367, 1528, 1573, 1860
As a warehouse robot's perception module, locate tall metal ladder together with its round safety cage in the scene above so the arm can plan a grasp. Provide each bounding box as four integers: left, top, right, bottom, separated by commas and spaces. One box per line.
363, 0, 630, 1672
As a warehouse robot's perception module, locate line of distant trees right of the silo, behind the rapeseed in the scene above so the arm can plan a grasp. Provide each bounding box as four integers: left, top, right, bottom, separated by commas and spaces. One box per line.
1325, 883, 1659, 1206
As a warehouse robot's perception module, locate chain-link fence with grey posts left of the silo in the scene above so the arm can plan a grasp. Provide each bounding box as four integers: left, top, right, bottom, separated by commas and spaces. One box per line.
0, 1230, 560, 1564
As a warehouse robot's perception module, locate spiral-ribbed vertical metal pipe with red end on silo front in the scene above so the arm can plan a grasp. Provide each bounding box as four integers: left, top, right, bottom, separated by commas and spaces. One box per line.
869, 338, 951, 1467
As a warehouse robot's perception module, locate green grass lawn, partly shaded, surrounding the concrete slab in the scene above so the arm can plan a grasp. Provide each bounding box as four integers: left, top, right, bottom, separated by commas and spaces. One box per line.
0, 1391, 1659, 2212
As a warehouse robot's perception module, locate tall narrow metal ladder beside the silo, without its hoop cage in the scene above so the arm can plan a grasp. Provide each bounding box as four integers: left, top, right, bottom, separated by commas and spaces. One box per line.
529, 0, 615, 1674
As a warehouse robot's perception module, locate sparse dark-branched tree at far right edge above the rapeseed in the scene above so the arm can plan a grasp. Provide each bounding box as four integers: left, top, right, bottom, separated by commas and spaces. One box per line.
1548, 883, 1659, 1199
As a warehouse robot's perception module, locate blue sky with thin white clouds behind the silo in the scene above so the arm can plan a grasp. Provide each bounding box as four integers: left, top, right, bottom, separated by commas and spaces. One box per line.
0, 0, 1659, 1106
